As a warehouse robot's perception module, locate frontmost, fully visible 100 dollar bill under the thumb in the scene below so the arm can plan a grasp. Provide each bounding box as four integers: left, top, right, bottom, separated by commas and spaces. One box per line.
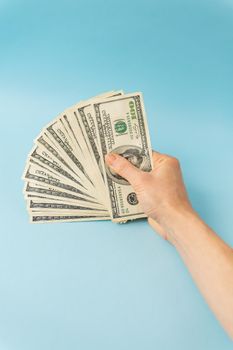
93, 93, 152, 222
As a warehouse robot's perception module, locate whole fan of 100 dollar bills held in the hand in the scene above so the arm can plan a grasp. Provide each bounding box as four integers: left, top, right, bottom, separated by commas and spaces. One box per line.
23, 91, 152, 223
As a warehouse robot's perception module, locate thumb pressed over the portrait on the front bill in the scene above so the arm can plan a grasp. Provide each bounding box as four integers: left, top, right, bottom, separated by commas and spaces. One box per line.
105, 153, 142, 186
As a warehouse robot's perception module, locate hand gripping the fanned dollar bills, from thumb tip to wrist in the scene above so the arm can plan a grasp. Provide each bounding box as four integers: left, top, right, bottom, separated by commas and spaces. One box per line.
105, 152, 193, 240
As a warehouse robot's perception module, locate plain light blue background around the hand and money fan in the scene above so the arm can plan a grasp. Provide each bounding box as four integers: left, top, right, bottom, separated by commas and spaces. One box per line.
0, 0, 233, 350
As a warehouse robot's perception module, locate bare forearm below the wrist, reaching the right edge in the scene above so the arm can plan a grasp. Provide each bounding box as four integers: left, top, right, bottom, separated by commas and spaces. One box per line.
166, 210, 233, 338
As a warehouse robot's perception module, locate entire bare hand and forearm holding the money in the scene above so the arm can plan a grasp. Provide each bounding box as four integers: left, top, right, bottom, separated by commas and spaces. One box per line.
105, 152, 233, 340
